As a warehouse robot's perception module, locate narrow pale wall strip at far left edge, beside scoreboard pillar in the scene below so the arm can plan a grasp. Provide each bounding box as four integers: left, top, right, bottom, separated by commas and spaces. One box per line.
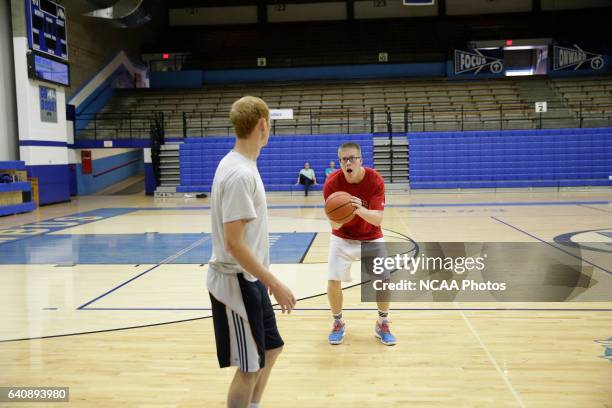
0, 0, 19, 161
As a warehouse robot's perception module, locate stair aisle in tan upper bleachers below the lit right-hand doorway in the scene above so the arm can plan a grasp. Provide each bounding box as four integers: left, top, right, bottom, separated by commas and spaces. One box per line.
516, 78, 580, 128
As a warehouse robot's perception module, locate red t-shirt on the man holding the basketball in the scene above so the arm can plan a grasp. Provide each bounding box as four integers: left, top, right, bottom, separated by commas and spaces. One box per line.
323, 167, 385, 241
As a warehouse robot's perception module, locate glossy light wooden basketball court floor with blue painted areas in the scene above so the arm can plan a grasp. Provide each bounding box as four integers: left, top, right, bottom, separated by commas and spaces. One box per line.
0, 190, 612, 408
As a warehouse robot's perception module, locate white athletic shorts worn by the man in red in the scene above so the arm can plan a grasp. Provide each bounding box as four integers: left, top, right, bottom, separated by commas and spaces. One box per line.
327, 234, 385, 282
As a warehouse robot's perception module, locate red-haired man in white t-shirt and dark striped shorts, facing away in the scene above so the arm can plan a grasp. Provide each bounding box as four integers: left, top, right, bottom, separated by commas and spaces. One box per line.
207, 96, 295, 408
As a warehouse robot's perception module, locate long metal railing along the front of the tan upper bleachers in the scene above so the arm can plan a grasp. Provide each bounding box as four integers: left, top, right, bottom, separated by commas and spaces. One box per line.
75, 101, 612, 140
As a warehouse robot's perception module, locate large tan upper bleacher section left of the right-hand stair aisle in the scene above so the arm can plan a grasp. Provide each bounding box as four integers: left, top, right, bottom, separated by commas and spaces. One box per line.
80, 80, 533, 138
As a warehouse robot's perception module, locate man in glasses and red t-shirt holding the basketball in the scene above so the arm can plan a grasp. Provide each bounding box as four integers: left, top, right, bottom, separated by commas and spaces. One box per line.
323, 142, 396, 346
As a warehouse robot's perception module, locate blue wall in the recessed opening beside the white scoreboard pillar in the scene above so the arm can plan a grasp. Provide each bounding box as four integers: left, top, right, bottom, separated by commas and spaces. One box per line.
77, 150, 144, 195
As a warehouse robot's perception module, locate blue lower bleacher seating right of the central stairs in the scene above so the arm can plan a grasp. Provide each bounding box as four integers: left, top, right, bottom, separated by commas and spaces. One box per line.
409, 128, 612, 189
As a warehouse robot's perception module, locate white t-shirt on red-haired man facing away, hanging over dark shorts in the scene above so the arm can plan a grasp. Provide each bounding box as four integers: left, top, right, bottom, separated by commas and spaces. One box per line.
207, 150, 270, 318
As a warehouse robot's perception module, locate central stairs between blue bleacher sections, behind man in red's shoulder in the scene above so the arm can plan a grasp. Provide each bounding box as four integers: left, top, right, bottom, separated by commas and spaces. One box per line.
374, 135, 409, 186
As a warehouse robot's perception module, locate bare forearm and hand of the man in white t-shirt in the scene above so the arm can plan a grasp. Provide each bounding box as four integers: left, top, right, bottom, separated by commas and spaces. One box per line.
223, 220, 296, 313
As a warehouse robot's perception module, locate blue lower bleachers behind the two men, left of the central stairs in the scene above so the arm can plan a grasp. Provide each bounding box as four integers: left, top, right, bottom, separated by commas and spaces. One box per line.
177, 134, 373, 192
